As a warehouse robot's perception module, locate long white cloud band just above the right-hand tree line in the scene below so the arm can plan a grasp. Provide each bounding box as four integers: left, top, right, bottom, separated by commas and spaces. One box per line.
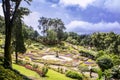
66, 20, 120, 34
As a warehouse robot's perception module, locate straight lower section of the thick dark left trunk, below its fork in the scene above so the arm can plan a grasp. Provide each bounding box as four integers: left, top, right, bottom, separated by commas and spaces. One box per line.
4, 23, 12, 69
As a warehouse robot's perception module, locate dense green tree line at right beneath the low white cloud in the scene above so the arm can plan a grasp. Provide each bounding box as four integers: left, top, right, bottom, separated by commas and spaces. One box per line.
66, 32, 120, 55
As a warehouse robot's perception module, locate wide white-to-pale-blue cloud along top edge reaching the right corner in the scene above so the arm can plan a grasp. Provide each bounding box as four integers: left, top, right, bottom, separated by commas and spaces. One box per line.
59, 0, 120, 13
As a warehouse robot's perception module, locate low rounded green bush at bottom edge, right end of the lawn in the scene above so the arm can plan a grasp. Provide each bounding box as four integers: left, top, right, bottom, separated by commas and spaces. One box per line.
66, 71, 83, 80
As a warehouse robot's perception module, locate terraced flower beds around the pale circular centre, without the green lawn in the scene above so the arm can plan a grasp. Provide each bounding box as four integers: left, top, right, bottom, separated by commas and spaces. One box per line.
13, 42, 99, 80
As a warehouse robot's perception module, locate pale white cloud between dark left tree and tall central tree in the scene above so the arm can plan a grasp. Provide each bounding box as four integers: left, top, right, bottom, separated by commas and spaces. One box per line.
23, 12, 40, 30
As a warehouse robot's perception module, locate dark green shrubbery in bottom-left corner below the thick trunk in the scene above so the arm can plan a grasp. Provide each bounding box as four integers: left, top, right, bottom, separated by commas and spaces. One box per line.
0, 66, 23, 80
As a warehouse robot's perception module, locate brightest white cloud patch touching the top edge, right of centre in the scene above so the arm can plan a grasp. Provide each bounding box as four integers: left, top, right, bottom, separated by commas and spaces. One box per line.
60, 0, 95, 9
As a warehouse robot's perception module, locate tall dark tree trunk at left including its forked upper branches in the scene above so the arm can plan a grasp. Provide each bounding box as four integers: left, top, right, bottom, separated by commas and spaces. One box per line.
2, 0, 22, 69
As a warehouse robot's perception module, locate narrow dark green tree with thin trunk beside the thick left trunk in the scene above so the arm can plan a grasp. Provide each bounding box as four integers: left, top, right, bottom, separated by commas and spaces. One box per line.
12, 7, 30, 63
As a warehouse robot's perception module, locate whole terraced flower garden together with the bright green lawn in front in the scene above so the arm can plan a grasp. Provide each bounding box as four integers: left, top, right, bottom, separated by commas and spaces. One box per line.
0, 34, 99, 80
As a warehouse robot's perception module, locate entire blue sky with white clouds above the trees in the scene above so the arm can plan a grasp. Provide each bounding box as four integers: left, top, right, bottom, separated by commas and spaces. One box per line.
0, 0, 120, 34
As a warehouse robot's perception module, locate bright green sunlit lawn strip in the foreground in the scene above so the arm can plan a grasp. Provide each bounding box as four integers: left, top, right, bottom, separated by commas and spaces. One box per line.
13, 64, 73, 80
